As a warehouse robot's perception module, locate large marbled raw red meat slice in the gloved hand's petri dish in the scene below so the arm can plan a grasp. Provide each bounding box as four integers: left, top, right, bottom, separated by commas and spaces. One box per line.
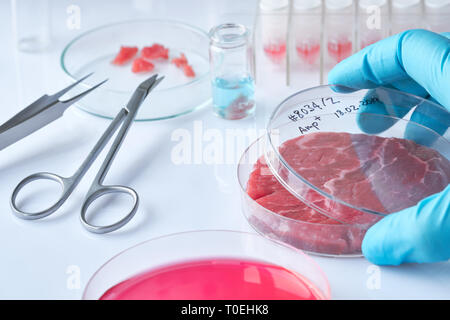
247, 132, 450, 254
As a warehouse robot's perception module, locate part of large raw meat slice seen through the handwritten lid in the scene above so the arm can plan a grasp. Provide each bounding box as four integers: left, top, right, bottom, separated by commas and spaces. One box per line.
280, 132, 450, 223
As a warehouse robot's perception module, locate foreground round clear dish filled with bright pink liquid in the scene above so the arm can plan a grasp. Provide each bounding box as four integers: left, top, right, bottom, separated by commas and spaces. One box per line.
83, 230, 330, 300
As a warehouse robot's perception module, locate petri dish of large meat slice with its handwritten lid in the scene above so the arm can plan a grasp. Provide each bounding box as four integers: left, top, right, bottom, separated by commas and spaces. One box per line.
238, 85, 450, 256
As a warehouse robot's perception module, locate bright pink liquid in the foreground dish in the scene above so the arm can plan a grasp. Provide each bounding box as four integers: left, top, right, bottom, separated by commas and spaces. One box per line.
100, 258, 323, 300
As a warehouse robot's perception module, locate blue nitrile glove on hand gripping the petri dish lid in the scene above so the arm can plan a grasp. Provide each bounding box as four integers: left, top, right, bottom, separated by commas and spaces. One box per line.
328, 30, 450, 265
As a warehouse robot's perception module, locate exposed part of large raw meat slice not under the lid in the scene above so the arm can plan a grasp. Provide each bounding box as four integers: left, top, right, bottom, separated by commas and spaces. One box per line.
247, 157, 356, 255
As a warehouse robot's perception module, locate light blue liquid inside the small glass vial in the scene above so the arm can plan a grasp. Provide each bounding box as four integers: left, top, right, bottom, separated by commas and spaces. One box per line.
212, 76, 255, 120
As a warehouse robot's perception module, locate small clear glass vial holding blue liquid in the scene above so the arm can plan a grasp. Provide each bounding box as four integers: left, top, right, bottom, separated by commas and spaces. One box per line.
209, 23, 255, 120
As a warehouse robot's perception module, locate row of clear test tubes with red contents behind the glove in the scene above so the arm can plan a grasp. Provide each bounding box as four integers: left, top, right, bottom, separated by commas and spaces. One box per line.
254, 0, 450, 88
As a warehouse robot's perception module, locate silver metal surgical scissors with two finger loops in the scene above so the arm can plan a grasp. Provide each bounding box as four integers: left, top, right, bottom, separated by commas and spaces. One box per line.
11, 75, 163, 233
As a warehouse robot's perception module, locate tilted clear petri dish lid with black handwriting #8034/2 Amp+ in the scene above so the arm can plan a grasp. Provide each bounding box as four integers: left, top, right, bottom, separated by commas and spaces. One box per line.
265, 85, 450, 226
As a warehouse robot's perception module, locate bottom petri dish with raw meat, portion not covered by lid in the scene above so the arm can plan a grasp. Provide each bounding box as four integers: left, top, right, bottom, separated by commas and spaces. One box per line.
237, 135, 368, 257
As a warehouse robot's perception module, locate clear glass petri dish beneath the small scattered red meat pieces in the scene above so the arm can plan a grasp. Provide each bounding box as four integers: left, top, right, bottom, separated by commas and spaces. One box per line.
60, 19, 211, 121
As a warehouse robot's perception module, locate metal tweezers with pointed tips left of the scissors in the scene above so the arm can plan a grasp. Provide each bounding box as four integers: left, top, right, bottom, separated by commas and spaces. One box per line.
0, 75, 106, 150
